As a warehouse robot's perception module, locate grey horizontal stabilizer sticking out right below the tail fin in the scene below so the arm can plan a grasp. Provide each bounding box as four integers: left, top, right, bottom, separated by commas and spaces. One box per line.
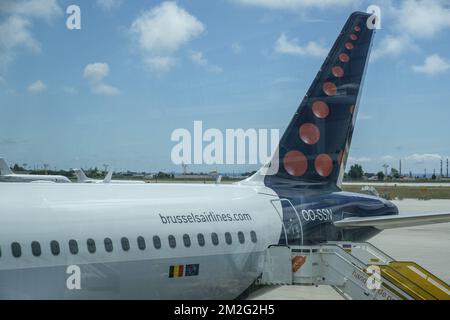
334, 213, 450, 230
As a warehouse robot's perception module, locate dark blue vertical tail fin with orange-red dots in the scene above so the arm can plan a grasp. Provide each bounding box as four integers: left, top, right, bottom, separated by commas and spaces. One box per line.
264, 12, 374, 189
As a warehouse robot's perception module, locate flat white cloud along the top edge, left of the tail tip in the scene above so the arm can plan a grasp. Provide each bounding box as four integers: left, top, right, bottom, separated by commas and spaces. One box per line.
235, 0, 359, 10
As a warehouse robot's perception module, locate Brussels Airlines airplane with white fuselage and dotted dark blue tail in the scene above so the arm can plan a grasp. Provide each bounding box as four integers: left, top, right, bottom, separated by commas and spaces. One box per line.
0, 12, 450, 299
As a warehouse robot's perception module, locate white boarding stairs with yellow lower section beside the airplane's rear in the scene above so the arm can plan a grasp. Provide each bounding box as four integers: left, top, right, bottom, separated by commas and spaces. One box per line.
258, 242, 450, 300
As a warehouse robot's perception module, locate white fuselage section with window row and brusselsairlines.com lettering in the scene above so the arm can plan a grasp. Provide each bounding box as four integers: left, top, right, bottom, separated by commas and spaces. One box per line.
0, 183, 282, 299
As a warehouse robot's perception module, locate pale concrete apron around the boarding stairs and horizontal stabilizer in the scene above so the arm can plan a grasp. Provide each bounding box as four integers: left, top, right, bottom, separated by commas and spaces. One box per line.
249, 199, 450, 300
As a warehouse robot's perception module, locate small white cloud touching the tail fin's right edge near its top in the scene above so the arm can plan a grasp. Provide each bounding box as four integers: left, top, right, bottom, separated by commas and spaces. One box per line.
371, 35, 416, 61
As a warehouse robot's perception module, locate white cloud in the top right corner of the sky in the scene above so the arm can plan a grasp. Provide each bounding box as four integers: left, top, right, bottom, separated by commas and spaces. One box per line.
397, 0, 450, 38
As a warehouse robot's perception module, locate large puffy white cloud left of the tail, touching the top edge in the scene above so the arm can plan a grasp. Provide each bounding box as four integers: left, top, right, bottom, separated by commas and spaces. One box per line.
130, 2, 205, 71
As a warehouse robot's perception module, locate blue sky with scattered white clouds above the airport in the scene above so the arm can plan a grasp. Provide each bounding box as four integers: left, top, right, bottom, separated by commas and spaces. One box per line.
0, 0, 450, 173
